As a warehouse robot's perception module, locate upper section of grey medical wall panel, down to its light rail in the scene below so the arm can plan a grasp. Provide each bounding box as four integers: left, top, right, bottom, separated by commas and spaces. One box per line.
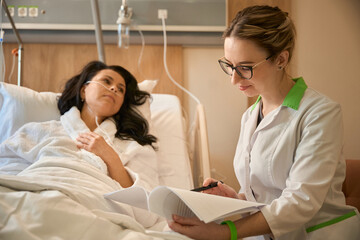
3, 0, 226, 32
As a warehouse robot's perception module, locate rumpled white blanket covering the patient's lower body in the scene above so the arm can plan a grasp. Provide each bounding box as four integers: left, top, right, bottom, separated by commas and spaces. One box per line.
0, 159, 188, 239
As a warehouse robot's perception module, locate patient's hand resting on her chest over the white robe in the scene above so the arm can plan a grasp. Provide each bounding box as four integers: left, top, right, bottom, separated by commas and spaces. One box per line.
76, 132, 117, 162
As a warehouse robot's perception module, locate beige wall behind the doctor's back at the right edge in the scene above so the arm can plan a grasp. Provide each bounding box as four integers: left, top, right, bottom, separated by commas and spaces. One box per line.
291, 0, 360, 159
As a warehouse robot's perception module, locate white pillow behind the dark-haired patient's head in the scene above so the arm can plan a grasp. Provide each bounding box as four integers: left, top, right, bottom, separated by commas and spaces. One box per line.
0, 80, 157, 143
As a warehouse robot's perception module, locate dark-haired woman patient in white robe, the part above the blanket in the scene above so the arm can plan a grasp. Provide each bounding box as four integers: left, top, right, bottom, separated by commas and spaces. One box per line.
0, 61, 158, 188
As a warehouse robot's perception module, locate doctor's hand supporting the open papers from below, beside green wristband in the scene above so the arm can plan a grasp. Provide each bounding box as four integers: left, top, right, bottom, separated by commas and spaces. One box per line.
168, 215, 230, 240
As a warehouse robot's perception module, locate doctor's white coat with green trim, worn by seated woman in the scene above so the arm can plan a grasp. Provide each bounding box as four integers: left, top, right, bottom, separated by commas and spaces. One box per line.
234, 79, 360, 240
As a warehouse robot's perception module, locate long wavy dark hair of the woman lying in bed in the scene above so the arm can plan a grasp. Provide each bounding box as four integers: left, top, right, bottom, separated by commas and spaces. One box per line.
58, 61, 157, 148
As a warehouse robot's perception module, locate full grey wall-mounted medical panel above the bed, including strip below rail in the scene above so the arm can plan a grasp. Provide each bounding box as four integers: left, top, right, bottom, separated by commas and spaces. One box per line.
2, 0, 226, 45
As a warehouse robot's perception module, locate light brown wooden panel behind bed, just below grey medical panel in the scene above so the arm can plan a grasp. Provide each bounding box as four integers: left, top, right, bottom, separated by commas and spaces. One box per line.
3, 43, 183, 102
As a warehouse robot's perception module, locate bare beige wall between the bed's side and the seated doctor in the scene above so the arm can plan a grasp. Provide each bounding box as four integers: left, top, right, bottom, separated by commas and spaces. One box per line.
184, 46, 247, 189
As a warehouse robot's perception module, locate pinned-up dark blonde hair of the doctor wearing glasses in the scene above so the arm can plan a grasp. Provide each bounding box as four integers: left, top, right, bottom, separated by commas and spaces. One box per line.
223, 6, 296, 61
